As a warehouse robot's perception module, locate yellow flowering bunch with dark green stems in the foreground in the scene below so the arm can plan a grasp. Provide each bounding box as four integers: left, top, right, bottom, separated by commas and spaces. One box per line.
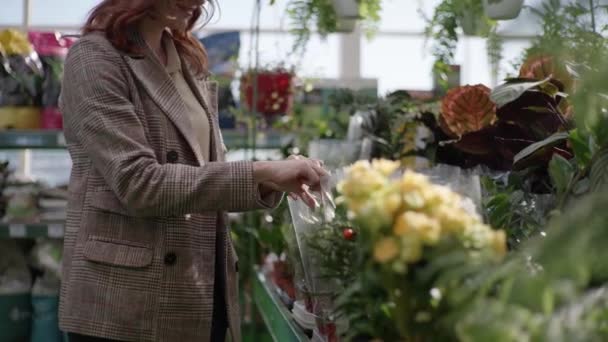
338, 160, 506, 341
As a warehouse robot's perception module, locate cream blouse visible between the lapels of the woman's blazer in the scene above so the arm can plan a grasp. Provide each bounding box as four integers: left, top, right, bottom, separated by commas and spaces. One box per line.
163, 39, 211, 162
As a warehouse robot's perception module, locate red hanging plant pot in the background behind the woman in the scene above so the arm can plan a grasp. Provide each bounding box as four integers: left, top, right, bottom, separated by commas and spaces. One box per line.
241, 71, 293, 116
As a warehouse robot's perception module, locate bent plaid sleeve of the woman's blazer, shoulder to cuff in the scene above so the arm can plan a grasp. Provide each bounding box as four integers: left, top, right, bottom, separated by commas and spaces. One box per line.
61, 38, 277, 216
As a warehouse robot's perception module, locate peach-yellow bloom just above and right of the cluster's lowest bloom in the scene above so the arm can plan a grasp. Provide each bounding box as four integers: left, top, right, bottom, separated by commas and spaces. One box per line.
393, 211, 441, 245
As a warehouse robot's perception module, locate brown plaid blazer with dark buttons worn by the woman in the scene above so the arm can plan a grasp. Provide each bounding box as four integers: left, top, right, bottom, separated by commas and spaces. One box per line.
59, 33, 281, 342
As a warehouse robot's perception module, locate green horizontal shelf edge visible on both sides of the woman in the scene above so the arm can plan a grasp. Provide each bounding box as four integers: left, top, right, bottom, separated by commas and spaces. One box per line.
0, 130, 290, 149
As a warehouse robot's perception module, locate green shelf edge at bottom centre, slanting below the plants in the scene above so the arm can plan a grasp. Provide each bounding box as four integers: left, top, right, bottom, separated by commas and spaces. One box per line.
253, 271, 310, 342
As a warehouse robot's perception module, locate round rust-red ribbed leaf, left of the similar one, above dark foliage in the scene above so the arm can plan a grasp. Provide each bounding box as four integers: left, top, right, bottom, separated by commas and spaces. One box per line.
439, 84, 496, 138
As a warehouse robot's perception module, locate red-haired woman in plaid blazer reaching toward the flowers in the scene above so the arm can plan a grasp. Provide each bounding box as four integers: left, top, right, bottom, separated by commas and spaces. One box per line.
60, 0, 325, 342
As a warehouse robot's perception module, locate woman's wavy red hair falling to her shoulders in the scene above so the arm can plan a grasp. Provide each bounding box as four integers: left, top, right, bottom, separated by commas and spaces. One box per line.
82, 0, 213, 76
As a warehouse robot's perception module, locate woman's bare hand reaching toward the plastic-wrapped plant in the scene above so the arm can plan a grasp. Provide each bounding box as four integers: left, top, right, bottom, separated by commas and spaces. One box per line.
253, 157, 327, 207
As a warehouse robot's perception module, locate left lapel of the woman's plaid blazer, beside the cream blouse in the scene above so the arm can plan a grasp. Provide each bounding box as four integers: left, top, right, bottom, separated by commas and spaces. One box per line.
125, 34, 204, 165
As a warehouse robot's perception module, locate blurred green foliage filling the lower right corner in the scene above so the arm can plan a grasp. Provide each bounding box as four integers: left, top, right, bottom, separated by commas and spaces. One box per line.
448, 193, 608, 341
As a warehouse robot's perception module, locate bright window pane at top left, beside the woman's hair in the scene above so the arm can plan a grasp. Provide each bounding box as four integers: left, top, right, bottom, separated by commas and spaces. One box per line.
30, 0, 101, 27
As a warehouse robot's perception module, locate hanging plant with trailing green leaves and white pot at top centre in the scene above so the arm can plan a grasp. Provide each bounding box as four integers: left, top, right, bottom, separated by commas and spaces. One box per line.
280, 0, 382, 53
